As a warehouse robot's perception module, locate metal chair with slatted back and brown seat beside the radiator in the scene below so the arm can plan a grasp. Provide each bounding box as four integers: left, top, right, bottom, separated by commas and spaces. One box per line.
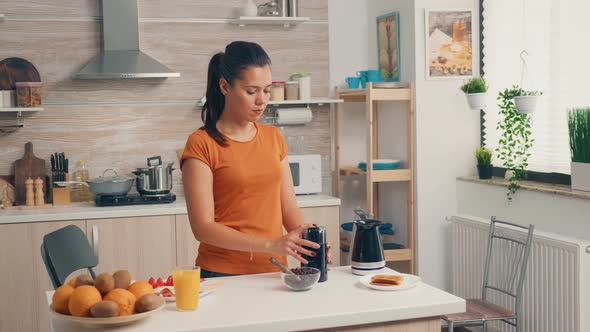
441, 216, 535, 332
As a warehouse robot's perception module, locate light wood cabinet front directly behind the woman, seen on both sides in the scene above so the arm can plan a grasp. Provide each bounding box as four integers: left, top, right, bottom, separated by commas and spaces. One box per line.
176, 206, 340, 267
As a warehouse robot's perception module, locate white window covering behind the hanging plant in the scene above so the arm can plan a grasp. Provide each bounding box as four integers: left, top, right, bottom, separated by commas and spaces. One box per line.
483, 0, 590, 174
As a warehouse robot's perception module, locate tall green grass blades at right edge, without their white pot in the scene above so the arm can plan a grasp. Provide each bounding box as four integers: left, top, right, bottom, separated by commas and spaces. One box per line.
567, 107, 590, 163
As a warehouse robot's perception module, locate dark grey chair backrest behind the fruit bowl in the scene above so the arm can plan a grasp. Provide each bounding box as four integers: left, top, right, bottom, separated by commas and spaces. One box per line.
41, 225, 98, 288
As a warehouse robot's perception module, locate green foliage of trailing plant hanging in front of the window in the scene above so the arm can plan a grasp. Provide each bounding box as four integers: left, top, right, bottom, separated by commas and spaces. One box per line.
496, 85, 535, 202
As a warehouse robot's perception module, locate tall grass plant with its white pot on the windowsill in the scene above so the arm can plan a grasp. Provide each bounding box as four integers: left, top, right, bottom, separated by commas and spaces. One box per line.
568, 107, 590, 191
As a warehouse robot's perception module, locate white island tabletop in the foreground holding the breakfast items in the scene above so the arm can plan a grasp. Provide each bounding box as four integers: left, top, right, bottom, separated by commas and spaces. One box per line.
47, 266, 465, 332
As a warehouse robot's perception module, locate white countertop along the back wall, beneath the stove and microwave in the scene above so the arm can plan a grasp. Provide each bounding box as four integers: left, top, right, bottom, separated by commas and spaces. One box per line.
0, 195, 340, 224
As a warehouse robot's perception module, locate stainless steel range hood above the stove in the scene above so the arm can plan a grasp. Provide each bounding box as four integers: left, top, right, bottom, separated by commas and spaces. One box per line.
74, 0, 180, 79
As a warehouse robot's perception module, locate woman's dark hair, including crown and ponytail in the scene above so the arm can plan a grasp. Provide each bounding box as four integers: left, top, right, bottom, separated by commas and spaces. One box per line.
201, 41, 270, 146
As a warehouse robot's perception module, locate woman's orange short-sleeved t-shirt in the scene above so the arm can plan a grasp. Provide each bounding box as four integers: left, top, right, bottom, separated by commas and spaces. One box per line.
180, 123, 287, 274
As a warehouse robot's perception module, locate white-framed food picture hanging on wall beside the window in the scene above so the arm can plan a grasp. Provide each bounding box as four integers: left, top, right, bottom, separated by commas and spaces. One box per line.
425, 9, 473, 79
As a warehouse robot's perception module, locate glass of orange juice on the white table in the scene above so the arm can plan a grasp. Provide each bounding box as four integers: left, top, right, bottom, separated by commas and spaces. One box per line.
172, 266, 201, 311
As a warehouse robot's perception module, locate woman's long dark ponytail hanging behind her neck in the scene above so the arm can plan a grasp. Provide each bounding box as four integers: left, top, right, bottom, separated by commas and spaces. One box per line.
201, 52, 227, 146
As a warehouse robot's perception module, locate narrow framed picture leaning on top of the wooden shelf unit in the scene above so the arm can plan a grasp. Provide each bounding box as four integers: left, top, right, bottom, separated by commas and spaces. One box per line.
377, 12, 400, 82
